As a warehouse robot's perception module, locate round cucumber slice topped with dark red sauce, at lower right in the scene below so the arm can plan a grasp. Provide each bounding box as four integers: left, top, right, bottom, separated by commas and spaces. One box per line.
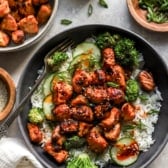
110, 137, 139, 166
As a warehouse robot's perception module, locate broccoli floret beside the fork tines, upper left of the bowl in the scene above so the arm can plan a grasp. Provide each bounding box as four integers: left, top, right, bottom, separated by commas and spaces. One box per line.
47, 52, 68, 68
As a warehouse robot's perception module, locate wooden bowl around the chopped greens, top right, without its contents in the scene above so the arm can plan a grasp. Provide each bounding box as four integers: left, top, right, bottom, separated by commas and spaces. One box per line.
127, 0, 168, 32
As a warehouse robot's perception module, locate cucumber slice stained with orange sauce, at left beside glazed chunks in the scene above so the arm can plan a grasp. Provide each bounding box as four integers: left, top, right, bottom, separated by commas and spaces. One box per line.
43, 94, 54, 121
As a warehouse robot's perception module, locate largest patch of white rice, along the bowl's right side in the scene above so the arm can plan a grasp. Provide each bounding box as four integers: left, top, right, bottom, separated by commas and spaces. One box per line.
134, 87, 162, 152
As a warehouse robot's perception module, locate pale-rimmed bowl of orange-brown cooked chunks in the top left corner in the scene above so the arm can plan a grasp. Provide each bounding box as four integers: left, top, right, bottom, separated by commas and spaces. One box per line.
0, 0, 58, 52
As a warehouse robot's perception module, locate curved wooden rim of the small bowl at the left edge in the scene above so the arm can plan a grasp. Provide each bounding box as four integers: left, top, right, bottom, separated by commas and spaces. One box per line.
0, 68, 16, 121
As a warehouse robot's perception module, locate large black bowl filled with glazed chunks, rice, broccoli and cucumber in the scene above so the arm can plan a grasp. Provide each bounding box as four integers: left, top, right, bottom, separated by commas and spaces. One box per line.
18, 25, 168, 168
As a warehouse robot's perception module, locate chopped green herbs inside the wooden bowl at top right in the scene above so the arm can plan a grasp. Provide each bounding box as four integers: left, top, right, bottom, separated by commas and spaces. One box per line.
139, 0, 168, 23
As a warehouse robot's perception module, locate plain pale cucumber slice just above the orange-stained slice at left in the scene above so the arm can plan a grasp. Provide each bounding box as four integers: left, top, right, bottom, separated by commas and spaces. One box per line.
43, 74, 54, 97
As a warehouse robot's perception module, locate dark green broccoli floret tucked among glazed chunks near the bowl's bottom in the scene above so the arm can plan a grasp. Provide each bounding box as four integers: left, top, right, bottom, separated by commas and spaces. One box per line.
64, 135, 86, 150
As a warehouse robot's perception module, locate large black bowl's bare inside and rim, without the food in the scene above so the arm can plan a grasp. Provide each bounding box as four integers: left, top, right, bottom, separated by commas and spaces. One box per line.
18, 25, 168, 168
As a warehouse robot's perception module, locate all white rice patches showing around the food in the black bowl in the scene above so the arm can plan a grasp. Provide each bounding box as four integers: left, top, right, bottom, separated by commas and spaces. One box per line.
31, 39, 163, 167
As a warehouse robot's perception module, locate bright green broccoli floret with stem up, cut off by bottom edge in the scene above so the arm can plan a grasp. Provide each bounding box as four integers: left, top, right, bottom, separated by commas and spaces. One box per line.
67, 153, 97, 168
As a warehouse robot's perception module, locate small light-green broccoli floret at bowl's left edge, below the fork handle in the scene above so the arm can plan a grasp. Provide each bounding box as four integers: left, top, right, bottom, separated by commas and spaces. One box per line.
28, 107, 44, 124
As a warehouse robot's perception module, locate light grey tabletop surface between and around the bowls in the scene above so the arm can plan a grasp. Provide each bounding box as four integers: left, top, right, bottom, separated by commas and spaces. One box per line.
0, 0, 168, 168
